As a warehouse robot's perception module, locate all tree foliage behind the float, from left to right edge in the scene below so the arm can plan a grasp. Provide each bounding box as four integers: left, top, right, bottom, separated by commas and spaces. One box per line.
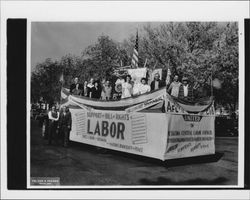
31, 22, 239, 109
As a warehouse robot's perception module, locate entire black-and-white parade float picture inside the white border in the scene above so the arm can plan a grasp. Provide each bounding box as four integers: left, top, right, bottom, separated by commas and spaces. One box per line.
30, 22, 239, 186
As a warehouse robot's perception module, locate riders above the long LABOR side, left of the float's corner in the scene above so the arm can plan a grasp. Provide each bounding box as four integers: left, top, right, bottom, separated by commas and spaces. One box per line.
70, 73, 166, 100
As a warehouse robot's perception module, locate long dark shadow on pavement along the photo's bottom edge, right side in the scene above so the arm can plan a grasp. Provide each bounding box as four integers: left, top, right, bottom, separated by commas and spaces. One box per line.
140, 177, 228, 185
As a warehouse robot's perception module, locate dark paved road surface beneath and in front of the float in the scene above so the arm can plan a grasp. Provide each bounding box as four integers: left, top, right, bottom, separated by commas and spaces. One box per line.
31, 121, 238, 186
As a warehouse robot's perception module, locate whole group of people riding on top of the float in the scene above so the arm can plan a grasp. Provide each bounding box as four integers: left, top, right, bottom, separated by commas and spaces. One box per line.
70, 73, 210, 100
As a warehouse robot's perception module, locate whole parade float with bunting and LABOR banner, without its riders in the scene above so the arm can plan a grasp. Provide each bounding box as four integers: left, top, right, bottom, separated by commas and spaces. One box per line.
61, 68, 215, 161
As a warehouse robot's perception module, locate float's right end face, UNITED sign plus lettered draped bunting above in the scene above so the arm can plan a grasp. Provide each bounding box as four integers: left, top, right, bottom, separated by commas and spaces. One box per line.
164, 96, 215, 159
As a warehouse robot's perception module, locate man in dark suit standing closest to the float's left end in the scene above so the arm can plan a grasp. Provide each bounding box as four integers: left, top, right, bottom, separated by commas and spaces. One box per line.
59, 106, 72, 147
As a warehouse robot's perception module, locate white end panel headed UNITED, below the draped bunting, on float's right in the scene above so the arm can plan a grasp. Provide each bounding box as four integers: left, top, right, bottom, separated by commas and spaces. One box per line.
165, 114, 215, 159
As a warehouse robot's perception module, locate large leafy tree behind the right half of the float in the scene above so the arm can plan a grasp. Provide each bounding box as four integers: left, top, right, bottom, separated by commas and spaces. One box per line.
139, 22, 238, 110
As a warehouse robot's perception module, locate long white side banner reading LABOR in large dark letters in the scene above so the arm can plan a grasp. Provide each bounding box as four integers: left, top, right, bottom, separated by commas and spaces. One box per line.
70, 109, 167, 160
